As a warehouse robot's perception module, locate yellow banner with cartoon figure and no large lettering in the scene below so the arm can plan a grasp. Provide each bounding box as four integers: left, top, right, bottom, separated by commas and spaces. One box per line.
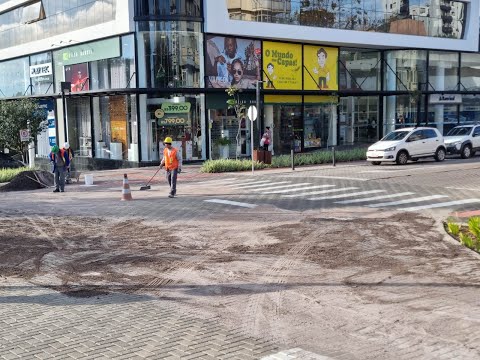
303, 45, 338, 90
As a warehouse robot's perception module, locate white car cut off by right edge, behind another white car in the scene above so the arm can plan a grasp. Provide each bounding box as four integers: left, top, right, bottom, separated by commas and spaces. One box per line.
444, 125, 480, 159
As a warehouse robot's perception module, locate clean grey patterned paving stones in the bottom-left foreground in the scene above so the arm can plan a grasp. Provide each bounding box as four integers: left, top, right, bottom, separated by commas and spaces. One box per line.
0, 279, 278, 359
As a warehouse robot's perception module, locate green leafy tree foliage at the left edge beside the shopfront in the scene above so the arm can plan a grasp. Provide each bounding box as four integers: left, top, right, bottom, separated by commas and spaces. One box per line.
0, 99, 48, 152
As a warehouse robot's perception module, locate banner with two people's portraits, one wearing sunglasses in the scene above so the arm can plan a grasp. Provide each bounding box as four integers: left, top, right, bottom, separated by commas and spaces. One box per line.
205, 35, 262, 89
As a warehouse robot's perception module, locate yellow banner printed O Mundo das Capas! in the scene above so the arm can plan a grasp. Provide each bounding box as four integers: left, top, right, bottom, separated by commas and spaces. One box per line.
263, 41, 302, 90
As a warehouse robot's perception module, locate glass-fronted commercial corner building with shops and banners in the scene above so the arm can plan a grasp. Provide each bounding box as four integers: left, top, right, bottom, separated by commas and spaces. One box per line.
0, 0, 480, 168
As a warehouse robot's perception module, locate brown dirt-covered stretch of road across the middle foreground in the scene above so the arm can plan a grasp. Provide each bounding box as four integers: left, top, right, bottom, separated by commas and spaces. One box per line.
0, 204, 480, 359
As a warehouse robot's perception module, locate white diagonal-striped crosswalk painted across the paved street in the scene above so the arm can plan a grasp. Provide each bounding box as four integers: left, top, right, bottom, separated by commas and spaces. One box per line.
200, 178, 480, 211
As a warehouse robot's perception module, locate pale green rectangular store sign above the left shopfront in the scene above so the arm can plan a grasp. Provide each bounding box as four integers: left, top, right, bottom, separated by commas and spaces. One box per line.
62, 38, 120, 65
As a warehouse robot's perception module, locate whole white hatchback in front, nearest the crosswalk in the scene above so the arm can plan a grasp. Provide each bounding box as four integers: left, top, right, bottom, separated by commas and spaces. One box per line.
367, 127, 447, 165
